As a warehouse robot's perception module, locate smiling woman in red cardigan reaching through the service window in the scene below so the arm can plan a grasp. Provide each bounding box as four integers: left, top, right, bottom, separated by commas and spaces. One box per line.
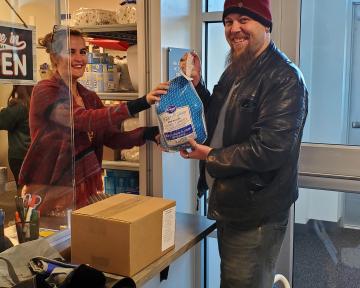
20, 29, 166, 213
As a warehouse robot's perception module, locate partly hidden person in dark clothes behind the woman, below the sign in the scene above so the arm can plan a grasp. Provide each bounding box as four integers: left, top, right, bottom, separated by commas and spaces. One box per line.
0, 85, 33, 188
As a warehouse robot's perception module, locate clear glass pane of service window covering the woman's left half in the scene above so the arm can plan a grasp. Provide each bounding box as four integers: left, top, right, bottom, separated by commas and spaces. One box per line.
0, 0, 75, 251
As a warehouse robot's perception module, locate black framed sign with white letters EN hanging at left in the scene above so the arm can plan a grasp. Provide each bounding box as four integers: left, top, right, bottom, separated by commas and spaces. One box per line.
0, 21, 36, 85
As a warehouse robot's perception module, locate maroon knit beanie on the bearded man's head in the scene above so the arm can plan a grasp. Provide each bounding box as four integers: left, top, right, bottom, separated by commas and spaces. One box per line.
223, 0, 272, 31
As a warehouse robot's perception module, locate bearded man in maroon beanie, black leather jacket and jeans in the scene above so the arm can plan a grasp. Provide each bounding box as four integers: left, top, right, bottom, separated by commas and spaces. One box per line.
180, 0, 308, 288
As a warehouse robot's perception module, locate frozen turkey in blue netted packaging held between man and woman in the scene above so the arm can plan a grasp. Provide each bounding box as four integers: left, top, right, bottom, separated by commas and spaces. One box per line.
155, 75, 207, 151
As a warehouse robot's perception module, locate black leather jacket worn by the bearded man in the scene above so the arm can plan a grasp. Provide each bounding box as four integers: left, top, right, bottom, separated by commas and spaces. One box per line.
196, 42, 308, 227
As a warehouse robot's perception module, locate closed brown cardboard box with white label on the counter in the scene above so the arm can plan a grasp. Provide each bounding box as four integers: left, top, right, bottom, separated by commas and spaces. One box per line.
71, 194, 175, 276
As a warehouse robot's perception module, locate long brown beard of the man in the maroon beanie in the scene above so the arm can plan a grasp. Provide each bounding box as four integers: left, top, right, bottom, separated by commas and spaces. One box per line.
225, 47, 256, 77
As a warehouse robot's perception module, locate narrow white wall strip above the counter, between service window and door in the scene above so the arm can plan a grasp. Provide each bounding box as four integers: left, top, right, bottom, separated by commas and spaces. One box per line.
161, 0, 200, 213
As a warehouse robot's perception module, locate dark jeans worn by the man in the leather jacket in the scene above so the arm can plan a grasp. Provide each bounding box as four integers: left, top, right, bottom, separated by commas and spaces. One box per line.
217, 213, 289, 288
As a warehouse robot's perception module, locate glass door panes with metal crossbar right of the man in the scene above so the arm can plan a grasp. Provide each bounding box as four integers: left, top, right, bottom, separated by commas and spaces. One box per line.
293, 0, 360, 288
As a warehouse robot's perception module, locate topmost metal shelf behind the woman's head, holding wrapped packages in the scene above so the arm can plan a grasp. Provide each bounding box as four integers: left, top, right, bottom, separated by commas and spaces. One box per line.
74, 24, 137, 45
